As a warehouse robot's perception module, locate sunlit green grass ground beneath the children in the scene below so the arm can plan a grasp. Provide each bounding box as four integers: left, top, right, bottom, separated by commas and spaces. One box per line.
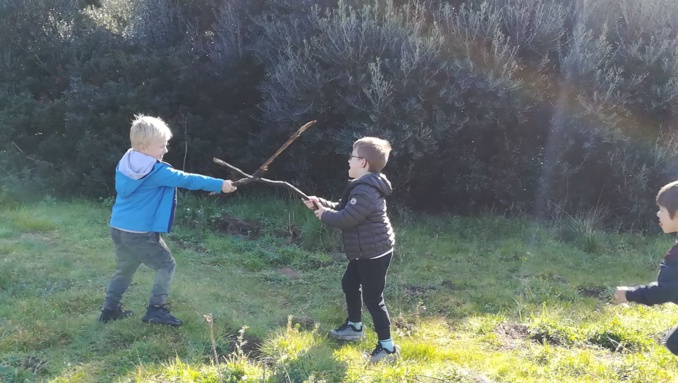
0, 195, 678, 382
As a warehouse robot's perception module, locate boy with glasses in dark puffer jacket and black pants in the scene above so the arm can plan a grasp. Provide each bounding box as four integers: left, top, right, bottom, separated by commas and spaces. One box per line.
304, 137, 398, 362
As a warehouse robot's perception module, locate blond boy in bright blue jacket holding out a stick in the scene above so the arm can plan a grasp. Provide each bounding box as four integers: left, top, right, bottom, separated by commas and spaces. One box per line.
99, 115, 236, 326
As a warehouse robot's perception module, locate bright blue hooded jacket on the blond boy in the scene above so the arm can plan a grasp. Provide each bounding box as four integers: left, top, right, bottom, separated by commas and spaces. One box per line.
110, 149, 223, 233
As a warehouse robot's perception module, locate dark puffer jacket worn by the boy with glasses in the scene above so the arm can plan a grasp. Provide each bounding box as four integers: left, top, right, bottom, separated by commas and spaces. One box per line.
320, 173, 395, 260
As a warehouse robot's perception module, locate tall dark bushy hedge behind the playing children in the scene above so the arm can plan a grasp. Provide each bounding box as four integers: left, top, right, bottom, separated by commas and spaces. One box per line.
0, 0, 678, 229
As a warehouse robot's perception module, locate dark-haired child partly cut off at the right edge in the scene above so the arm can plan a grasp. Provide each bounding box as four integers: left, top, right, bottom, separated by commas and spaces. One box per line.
613, 181, 678, 355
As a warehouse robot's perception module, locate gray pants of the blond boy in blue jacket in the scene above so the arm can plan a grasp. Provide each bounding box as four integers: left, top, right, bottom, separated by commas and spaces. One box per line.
103, 228, 176, 310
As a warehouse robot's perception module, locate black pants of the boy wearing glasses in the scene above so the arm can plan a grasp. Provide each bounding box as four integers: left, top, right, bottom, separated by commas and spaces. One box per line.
341, 253, 393, 340
